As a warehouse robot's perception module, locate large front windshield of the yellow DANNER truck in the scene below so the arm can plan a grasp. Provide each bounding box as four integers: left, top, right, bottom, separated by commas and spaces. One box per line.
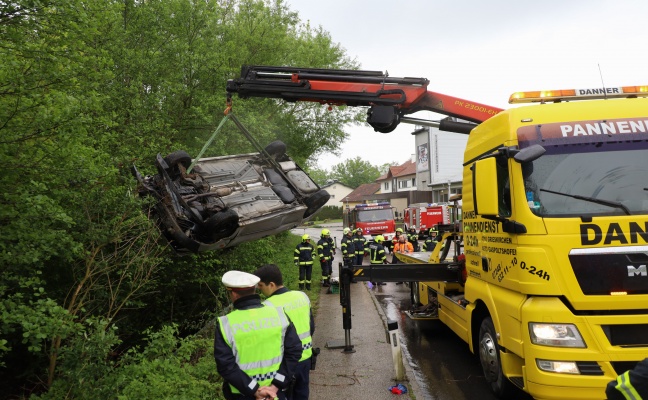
522, 141, 648, 217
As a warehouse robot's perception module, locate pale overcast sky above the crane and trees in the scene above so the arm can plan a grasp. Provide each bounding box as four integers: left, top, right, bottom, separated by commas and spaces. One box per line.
285, 0, 648, 170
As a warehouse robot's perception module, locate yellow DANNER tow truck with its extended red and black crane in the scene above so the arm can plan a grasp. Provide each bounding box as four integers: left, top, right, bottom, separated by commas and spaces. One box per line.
228, 67, 648, 400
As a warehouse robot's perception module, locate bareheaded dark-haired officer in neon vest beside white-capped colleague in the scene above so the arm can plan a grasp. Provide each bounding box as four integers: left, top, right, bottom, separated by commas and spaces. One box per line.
254, 264, 315, 400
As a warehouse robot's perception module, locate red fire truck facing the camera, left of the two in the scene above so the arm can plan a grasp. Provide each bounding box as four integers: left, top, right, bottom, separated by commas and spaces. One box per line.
344, 202, 396, 242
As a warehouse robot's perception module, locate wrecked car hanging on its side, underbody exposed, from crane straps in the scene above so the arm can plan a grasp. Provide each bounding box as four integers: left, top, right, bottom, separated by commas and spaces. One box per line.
133, 141, 330, 254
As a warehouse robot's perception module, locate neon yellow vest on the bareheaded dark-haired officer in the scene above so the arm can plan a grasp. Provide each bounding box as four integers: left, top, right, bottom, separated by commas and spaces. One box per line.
263, 290, 313, 361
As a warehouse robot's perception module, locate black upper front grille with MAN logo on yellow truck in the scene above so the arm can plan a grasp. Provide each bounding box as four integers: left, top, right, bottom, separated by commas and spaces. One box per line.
569, 246, 648, 295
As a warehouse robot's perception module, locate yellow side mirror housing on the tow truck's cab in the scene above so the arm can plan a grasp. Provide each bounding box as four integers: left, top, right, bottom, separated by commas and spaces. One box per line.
471, 157, 499, 216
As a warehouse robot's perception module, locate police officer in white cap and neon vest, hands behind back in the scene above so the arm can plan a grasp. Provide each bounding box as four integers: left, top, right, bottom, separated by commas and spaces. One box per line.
214, 271, 302, 400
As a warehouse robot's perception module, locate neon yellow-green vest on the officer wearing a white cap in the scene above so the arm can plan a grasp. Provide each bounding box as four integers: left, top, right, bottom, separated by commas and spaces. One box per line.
218, 306, 289, 394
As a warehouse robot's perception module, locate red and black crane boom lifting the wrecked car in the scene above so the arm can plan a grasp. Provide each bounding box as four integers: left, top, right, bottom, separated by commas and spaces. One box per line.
227, 65, 502, 132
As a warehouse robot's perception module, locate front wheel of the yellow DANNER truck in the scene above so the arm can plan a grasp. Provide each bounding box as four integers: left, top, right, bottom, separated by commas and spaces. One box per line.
479, 317, 515, 399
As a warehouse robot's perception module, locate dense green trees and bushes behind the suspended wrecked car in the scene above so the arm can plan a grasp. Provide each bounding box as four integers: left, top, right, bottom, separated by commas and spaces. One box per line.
0, 0, 340, 399
